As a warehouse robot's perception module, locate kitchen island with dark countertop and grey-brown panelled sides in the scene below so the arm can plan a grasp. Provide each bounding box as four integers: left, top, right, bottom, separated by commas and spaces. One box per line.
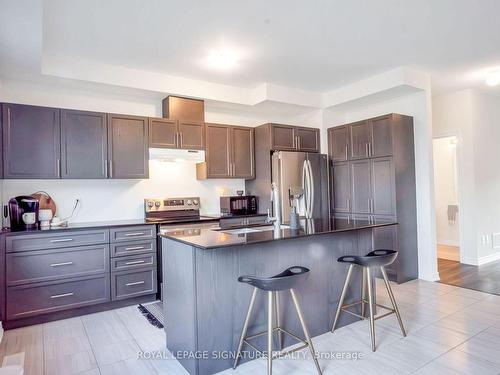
160, 219, 397, 375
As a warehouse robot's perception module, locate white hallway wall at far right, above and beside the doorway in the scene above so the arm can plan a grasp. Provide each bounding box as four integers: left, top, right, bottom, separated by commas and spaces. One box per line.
433, 90, 500, 264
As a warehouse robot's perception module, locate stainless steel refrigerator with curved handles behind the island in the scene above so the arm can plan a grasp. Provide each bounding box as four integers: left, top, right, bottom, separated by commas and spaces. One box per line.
272, 151, 329, 224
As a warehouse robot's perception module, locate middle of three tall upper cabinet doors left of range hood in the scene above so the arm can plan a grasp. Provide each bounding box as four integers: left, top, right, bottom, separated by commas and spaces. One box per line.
61, 110, 108, 178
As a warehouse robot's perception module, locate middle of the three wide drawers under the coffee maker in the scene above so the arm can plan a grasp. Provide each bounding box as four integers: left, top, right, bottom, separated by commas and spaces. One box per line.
6, 245, 109, 286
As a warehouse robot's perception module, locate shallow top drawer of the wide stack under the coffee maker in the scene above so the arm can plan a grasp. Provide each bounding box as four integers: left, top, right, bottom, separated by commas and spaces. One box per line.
5, 229, 109, 253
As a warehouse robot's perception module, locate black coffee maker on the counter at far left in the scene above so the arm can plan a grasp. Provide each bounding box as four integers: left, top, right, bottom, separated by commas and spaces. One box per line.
9, 195, 40, 231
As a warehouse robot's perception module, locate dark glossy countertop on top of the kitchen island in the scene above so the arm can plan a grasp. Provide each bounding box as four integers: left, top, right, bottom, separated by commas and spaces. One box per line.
160, 219, 397, 249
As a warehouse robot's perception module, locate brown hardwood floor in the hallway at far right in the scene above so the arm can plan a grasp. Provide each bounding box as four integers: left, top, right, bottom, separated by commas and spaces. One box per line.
438, 258, 500, 295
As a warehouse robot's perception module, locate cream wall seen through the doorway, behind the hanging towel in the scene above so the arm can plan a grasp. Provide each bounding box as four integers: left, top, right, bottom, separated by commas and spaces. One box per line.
433, 136, 460, 246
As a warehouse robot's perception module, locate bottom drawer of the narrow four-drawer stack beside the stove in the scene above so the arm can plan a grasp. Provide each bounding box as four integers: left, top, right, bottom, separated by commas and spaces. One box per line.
111, 267, 156, 300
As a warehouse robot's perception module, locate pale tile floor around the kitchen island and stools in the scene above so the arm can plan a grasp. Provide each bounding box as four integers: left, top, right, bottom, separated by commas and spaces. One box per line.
0, 281, 500, 375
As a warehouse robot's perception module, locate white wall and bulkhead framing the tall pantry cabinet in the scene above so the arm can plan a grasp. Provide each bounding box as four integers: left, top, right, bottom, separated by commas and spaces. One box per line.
324, 90, 439, 280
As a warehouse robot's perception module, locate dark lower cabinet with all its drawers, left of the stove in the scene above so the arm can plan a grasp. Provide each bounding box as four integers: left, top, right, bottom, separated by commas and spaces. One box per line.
0, 225, 157, 326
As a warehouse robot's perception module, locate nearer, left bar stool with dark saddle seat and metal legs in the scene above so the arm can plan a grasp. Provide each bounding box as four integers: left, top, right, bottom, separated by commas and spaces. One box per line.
233, 266, 322, 375
